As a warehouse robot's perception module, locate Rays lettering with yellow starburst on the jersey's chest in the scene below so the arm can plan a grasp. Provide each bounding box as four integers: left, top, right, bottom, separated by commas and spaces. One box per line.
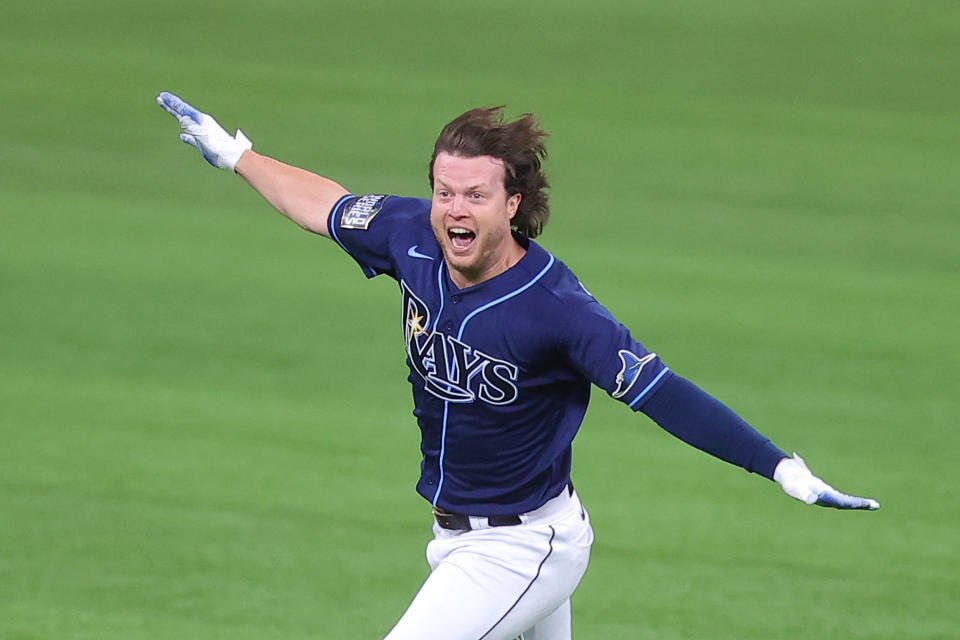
400, 281, 520, 405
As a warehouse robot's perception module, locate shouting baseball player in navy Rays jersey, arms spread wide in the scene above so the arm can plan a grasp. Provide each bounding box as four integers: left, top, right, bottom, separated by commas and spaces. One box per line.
157, 92, 880, 640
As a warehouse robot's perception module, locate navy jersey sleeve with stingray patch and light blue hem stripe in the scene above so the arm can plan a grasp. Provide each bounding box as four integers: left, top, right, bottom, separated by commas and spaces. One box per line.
560, 297, 673, 411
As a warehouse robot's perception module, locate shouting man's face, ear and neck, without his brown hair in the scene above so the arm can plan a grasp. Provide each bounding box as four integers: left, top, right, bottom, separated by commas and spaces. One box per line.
430, 152, 524, 288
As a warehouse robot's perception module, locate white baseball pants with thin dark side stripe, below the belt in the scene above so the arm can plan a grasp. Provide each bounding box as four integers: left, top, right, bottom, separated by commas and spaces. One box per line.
385, 489, 593, 640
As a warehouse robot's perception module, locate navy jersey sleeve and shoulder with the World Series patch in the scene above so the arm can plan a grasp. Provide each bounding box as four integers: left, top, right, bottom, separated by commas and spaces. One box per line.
327, 194, 430, 278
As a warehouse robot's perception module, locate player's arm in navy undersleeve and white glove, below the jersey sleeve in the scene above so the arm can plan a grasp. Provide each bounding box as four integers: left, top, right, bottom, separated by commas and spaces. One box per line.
640, 375, 880, 510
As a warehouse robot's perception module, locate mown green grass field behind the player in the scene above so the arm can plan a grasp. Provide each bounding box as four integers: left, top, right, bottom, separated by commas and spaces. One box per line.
0, 0, 960, 640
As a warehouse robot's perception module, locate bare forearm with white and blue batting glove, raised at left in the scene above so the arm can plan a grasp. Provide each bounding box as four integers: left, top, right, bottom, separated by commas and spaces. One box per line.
157, 91, 349, 237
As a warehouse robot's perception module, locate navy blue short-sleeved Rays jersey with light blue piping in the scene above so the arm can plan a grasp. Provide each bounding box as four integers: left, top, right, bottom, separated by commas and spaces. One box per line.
329, 195, 672, 515
